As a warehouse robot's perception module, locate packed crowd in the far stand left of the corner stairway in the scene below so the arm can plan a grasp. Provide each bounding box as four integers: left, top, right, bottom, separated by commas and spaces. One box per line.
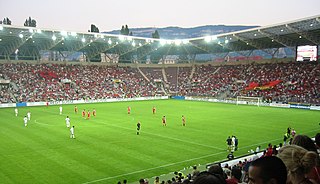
0, 63, 156, 103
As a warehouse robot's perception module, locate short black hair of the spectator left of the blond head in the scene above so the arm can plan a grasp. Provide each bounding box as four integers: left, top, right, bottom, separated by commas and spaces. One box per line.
250, 156, 287, 184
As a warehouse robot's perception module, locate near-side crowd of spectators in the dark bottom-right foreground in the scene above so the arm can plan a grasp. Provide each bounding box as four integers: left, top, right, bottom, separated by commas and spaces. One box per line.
132, 133, 320, 184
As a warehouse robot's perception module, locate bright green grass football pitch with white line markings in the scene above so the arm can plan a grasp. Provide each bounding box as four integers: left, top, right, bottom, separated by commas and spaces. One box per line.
0, 100, 320, 184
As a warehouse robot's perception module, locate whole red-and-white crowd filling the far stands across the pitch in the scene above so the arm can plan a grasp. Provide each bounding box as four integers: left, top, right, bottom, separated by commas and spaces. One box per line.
0, 62, 320, 104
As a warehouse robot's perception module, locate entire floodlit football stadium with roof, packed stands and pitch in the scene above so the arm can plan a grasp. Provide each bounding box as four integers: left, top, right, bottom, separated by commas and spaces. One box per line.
0, 7, 320, 184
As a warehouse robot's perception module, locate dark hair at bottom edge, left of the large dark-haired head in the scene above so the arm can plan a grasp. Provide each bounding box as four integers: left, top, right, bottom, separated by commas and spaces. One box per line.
193, 171, 226, 184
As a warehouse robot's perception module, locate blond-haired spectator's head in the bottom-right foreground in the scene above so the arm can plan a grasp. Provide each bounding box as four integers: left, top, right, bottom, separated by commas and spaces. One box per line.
278, 145, 317, 184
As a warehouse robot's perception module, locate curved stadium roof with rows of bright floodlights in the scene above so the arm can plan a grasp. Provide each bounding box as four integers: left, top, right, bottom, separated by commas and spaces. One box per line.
0, 15, 320, 60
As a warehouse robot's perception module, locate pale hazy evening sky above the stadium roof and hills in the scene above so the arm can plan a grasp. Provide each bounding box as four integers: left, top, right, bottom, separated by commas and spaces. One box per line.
0, 0, 320, 32
